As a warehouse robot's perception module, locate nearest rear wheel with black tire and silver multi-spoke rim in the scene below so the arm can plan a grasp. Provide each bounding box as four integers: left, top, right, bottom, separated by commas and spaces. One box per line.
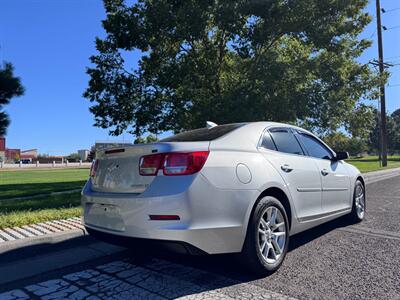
242, 196, 289, 275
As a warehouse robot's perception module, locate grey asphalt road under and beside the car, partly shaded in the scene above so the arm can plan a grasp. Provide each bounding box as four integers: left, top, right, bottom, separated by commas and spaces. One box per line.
0, 177, 400, 299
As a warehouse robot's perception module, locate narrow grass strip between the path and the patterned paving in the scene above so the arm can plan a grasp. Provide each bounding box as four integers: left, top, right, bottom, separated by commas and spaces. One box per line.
0, 192, 82, 228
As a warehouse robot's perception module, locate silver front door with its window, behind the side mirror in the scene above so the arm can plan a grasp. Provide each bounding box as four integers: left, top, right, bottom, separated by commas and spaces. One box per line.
297, 131, 351, 214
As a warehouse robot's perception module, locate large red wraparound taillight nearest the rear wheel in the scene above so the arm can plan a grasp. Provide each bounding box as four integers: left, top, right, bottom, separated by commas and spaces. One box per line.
139, 151, 209, 176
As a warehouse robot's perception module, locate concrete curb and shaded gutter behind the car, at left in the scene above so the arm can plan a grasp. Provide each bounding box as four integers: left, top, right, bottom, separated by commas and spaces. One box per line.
0, 228, 125, 287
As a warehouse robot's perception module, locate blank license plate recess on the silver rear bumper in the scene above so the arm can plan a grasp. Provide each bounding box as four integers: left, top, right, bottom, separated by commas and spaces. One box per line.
84, 203, 125, 231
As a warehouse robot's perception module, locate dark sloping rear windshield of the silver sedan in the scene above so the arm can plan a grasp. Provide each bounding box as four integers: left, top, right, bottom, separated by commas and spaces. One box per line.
160, 123, 244, 142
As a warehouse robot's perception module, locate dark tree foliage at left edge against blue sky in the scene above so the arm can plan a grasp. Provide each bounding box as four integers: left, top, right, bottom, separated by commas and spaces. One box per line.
0, 63, 24, 136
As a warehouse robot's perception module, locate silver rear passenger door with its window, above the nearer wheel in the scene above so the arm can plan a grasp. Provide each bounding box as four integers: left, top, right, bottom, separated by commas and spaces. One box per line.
260, 127, 321, 221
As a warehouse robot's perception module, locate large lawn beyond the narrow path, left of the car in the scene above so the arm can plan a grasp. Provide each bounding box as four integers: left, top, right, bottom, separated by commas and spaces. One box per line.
0, 168, 89, 200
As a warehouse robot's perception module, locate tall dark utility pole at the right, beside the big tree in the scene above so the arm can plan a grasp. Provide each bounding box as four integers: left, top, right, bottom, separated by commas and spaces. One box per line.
376, 0, 387, 167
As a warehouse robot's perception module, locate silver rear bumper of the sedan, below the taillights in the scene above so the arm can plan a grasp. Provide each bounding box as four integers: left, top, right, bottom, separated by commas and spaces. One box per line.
82, 174, 258, 254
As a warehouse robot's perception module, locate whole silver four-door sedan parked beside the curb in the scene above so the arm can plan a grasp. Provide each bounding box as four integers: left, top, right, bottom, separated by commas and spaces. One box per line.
82, 122, 365, 273
